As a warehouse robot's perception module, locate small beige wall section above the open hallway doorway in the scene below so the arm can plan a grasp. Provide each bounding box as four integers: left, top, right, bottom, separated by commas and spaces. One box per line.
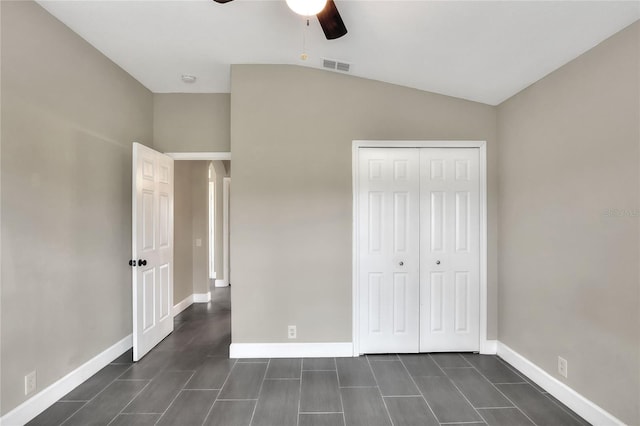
153, 93, 230, 152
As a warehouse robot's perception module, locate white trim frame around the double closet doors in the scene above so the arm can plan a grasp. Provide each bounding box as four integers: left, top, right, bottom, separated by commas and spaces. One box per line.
351, 140, 495, 356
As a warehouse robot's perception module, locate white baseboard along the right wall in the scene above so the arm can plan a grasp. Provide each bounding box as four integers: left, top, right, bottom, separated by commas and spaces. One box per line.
498, 342, 624, 426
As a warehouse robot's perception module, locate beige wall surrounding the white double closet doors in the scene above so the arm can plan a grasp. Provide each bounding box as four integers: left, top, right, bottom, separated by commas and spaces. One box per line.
231, 65, 497, 343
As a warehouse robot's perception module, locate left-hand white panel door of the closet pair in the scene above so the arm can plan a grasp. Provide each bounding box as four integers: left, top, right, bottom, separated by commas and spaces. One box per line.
358, 148, 420, 353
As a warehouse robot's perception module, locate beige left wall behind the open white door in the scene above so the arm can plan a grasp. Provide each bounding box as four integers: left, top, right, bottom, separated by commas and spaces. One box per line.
0, 1, 153, 413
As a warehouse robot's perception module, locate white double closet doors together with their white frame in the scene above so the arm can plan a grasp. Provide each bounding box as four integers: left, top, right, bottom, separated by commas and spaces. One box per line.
353, 141, 486, 355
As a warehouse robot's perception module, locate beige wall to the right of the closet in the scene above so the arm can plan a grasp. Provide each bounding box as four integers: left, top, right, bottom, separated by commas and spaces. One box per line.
498, 24, 640, 425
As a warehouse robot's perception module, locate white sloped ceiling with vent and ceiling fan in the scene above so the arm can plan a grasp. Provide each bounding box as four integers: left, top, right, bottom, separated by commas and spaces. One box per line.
39, 0, 640, 105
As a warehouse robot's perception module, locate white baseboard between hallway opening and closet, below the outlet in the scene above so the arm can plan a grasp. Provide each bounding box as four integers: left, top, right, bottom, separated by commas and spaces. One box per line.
229, 342, 353, 358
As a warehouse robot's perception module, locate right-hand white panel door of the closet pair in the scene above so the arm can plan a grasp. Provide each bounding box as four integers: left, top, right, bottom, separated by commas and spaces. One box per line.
420, 148, 480, 352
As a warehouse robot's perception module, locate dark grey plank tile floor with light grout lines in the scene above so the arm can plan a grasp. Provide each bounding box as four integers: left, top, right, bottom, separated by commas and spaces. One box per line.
29, 289, 588, 426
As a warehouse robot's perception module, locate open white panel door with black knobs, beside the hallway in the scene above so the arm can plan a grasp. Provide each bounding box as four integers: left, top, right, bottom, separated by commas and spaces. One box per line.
132, 143, 173, 361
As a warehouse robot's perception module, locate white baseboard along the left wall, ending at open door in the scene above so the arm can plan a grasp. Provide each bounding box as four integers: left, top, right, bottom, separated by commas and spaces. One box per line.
0, 334, 133, 426
